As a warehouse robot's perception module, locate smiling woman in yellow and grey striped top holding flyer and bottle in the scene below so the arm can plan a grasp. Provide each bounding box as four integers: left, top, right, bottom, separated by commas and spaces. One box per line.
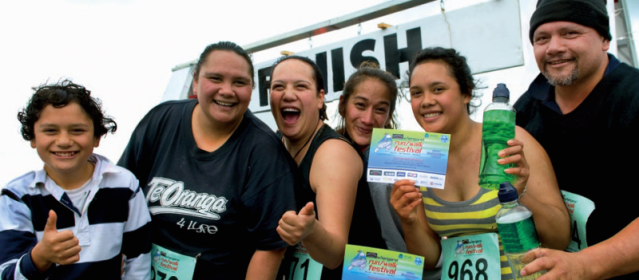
391, 48, 570, 279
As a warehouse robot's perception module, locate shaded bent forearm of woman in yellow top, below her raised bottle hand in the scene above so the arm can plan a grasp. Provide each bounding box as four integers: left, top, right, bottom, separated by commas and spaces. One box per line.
520, 194, 570, 250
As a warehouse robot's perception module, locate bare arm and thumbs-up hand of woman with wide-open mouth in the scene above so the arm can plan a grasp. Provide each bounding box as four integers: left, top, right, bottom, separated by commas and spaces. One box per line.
277, 140, 363, 269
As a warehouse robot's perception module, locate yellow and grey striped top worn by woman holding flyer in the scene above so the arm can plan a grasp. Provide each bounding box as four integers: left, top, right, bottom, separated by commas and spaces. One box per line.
419, 187, 513, 280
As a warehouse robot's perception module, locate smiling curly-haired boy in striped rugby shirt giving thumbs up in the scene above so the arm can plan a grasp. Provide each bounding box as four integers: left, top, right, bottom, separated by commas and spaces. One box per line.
0, 80, 151, 279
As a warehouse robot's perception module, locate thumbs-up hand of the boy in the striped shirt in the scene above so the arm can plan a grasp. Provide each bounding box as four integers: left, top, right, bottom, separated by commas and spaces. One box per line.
31, 210, 81, 272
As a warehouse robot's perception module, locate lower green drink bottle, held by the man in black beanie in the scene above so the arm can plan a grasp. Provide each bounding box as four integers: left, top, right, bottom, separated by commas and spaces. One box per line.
495, 182, 545, 279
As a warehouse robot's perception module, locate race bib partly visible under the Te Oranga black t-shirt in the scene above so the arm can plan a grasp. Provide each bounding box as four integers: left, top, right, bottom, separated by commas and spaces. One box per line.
151, 244, 196, 280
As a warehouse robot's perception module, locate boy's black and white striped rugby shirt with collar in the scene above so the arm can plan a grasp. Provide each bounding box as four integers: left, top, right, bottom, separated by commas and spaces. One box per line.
0, 154, 151, 280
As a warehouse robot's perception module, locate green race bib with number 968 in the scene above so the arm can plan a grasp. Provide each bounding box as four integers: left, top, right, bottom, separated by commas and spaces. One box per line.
441, 233, 501, 280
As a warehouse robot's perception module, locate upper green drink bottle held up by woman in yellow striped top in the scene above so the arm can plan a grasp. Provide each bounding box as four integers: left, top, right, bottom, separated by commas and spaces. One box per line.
479, 84, 517, 190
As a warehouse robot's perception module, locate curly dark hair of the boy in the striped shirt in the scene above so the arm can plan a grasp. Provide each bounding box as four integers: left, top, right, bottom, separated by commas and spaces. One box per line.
18, 80, 118, 141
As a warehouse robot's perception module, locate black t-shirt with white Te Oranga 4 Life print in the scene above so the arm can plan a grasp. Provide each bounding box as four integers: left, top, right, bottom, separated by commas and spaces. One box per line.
118, 100, 296, 279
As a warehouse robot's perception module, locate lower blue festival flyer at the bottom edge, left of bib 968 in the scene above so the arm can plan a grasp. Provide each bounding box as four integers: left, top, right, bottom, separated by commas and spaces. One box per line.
342, 244, 424, 280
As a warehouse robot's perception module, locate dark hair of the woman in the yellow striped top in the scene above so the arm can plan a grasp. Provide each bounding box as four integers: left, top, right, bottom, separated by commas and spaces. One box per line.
406, 47, 481, 114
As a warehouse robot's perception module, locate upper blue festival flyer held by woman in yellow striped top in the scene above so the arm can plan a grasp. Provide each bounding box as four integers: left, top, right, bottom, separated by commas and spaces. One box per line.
367, 128, 450, 189
